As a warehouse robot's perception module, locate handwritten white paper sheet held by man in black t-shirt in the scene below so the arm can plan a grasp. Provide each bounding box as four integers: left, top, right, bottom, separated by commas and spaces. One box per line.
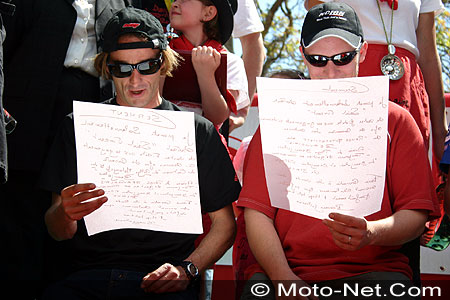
73, 101, 203, 236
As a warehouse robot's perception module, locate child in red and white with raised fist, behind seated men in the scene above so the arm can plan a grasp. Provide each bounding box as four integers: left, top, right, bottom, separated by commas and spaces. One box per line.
168, 0, 250, 128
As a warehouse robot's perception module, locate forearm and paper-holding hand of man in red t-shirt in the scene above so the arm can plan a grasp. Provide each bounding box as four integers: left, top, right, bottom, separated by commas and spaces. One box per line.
323, 209, 428, 250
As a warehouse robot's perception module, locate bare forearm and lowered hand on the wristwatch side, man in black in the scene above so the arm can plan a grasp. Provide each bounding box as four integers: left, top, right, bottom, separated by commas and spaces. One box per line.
141, 205, 236, 293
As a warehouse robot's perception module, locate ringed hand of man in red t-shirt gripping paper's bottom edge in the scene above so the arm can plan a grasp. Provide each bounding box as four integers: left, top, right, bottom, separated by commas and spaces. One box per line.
323, 213, 372, 251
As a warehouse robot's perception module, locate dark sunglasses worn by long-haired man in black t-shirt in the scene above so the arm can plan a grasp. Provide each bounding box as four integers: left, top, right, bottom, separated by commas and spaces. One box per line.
108, 53, 163, 78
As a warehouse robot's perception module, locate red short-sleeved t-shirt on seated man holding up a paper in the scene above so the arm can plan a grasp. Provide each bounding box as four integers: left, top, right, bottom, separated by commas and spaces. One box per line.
237, 103, 439, 283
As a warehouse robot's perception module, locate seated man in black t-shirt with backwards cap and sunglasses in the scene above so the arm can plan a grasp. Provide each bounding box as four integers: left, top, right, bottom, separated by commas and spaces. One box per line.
41, 7, 240, 299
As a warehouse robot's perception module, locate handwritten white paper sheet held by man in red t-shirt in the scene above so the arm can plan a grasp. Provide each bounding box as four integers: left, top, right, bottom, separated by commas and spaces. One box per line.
257, 76, 389, 219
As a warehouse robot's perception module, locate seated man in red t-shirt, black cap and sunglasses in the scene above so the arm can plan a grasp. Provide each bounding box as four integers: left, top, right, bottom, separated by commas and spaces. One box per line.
238, 2, 439, 299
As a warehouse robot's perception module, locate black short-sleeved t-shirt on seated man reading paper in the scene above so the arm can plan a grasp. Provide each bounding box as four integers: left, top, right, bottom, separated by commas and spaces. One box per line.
40, 99, 240, 272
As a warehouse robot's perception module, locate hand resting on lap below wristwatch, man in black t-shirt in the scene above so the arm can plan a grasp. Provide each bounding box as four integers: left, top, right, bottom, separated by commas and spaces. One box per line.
141, 263, 189, 294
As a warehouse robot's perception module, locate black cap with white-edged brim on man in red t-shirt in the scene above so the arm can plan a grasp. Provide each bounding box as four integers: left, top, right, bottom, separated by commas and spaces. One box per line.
302, 2, 364, 49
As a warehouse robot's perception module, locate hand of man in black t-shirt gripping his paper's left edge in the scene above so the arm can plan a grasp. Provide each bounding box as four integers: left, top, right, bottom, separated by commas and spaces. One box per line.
59, 183, 108, 221
